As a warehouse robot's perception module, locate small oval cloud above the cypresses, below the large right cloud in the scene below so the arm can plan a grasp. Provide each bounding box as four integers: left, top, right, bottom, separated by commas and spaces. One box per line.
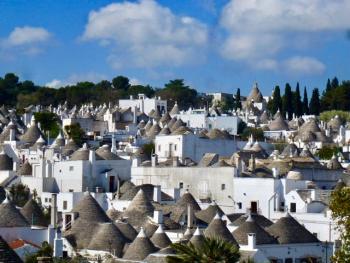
283, 56, 326, 75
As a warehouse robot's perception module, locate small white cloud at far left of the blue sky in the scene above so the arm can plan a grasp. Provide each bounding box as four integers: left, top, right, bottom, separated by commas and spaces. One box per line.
6, 26, 50, 46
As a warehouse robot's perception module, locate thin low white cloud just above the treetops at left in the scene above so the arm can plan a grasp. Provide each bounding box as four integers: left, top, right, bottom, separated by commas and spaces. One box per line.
45, 72, 107, 89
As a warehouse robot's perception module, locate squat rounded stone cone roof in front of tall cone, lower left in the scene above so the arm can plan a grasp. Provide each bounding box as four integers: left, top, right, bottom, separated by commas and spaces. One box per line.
87, 222, 127, 257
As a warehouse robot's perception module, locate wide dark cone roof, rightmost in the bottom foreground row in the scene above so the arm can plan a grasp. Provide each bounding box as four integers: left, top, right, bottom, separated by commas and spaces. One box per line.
266, 214, 320, 244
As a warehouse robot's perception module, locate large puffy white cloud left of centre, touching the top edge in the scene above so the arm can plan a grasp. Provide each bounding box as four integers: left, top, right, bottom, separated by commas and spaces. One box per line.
82, 0, 208, 68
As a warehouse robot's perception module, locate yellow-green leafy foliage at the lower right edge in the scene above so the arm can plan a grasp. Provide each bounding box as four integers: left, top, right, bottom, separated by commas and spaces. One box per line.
329, 186, 350, 263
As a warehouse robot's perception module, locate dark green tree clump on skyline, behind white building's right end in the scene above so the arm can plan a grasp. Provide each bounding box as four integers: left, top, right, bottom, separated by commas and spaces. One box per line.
156, 79, 197, 110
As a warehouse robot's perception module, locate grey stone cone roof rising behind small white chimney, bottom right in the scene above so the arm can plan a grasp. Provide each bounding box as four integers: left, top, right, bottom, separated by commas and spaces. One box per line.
232, 217, 278, 245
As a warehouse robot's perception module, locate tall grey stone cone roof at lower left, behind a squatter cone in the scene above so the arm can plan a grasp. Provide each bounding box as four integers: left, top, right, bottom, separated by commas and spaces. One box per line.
64, 193, 110, 249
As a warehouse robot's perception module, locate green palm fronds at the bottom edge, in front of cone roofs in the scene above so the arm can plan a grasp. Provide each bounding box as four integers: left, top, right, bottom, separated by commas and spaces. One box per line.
167, 238, 240, 263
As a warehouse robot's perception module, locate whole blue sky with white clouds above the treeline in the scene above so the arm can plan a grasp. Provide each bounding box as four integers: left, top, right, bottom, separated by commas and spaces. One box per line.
0, 0, 350, 94
